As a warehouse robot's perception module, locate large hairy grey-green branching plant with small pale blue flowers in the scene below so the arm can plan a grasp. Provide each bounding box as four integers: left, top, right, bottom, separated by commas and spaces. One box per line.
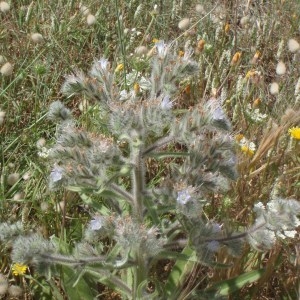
0, 41, 300, 299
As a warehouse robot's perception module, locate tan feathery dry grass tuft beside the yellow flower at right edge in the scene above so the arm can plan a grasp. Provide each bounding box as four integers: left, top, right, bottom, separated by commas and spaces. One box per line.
250, 108, 300, 169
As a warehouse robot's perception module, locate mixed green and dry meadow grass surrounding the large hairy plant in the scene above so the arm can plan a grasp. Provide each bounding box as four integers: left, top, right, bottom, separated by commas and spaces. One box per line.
0, 0, 300, 299
